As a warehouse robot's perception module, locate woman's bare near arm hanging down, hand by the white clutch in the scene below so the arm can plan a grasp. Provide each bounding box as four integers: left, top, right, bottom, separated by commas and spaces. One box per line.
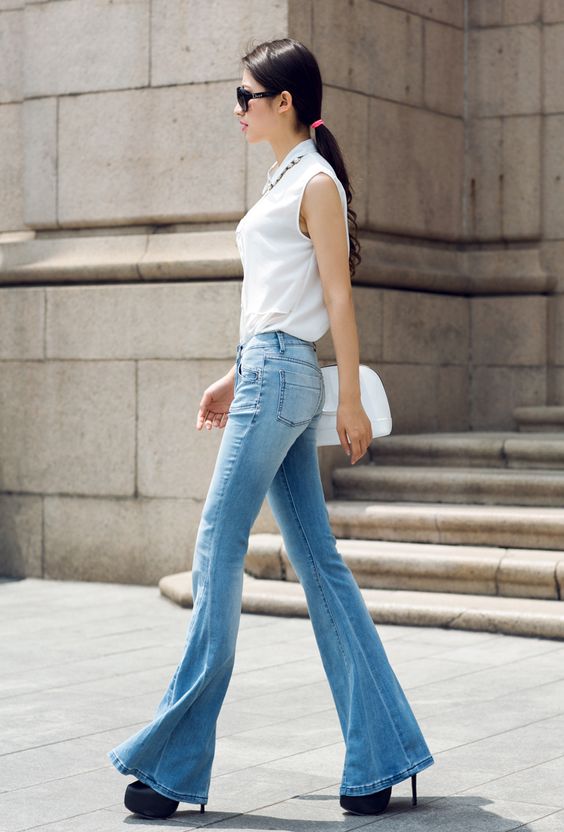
301, 173, 372, 464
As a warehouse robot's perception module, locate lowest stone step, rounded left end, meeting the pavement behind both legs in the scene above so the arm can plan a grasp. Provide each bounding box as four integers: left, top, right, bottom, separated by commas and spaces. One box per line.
159, 572, 564, 639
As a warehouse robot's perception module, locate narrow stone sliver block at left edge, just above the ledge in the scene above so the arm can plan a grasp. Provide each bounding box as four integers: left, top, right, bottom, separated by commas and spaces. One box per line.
0, 103, 24, 232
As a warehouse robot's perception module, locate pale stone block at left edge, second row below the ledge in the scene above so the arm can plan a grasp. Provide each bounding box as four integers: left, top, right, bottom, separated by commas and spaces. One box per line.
0, 361, 135, 496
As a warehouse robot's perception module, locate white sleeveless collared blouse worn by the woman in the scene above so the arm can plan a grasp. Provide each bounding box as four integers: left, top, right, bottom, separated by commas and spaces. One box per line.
235, 139, 350, 344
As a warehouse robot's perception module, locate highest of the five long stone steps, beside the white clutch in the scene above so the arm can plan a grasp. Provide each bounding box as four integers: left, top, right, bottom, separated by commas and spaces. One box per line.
369, 431, 564, 469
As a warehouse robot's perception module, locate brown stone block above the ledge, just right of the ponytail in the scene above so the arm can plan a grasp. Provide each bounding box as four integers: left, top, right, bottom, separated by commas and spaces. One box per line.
367, 100, 464, 239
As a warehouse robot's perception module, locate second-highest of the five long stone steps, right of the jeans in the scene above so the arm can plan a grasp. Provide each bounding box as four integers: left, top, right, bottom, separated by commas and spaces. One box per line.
333, 464, 564, 506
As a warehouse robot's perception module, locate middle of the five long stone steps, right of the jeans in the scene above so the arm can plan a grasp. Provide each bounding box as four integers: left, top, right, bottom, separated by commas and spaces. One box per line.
326, 500, 564, 549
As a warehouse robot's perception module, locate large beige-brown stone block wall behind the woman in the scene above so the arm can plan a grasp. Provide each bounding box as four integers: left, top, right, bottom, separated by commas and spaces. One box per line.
0, 0, 564, 584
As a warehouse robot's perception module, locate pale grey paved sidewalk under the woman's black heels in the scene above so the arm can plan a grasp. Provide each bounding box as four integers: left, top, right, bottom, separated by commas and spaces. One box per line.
0, 579, 564, 832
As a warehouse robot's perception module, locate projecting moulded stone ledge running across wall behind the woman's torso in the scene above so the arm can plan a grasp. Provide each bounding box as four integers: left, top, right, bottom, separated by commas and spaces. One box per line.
0, 229, 556, 295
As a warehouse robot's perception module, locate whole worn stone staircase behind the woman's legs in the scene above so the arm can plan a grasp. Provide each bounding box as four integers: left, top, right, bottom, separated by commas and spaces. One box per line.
160, 426, 564, 639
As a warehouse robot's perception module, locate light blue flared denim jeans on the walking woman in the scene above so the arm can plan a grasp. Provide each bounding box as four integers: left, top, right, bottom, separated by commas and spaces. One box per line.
108, 330, 434, 804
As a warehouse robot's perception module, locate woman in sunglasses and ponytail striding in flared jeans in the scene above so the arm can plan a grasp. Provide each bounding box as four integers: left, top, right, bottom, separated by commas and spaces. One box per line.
108, 38, 434, 818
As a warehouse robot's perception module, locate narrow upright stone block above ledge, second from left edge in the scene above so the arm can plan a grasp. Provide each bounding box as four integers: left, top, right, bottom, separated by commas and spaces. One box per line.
22, 98, 57, 228
